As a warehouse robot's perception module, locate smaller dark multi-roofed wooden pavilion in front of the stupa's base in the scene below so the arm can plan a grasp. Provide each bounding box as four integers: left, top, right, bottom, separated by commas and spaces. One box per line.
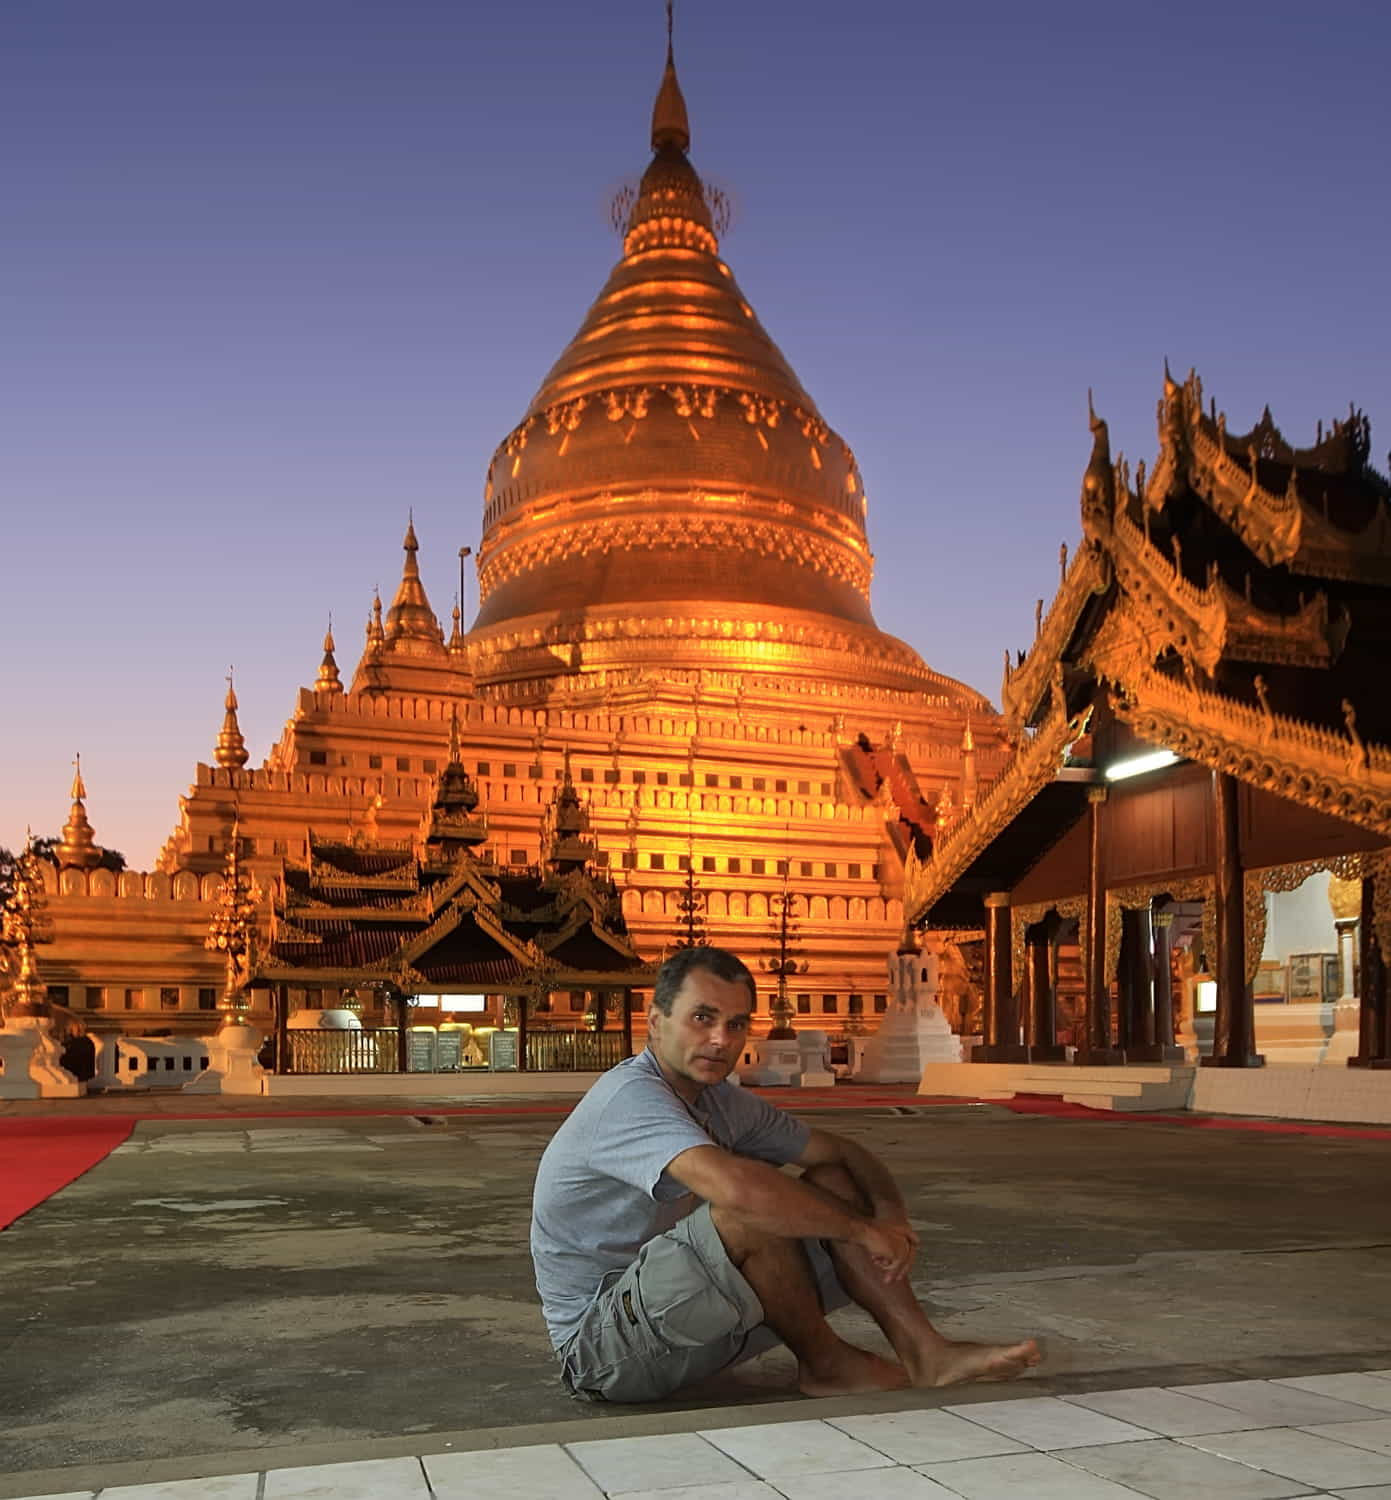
254, 720, 653, 1073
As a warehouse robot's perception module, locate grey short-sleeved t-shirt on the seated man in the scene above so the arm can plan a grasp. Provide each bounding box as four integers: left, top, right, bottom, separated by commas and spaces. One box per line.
531, 1052, 812, 1349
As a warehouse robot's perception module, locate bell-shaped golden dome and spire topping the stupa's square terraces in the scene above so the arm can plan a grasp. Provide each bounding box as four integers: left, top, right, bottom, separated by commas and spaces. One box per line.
470, 41, 956, 702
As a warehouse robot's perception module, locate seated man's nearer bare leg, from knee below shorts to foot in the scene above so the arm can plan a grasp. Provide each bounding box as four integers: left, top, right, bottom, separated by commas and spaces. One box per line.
710, 1208, 909, 1397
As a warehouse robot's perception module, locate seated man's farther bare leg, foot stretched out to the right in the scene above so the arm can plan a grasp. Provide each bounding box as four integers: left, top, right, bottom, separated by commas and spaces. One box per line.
803, 1167, 1043, 1386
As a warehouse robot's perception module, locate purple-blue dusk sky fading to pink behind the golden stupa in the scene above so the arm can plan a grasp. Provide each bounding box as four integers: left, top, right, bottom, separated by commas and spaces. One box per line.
0, 0, 1391, 867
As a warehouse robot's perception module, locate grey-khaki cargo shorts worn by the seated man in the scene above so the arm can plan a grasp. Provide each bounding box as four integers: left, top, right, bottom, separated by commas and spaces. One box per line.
557, 1203, 849, 1401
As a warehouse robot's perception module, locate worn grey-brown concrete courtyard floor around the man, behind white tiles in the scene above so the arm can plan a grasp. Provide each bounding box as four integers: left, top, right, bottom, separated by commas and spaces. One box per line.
0, 1103, 1391, 1496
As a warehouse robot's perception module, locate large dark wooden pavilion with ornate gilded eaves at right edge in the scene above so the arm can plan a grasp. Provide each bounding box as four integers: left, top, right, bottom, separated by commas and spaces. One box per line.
903, 371, 1391, 1068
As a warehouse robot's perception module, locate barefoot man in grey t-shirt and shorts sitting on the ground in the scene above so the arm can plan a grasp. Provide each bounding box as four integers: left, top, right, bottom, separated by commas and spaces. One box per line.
531, 948, 1040, 1401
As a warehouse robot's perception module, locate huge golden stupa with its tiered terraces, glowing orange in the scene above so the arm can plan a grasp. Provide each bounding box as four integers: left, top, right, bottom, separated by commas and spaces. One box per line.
38, 35, 1005, 1031
